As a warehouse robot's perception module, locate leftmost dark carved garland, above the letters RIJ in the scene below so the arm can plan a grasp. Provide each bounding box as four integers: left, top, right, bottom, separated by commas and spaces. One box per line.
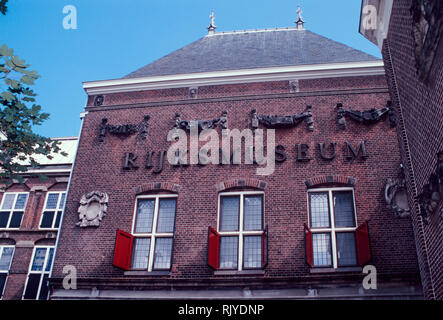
98, 115, 150, 142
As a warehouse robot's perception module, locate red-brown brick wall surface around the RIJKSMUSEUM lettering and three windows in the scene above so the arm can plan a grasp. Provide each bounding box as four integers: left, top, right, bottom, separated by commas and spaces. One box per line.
52, 76, 418, 287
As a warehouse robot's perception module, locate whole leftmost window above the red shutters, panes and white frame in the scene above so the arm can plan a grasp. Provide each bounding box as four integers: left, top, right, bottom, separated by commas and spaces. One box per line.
131, 195, 177, 272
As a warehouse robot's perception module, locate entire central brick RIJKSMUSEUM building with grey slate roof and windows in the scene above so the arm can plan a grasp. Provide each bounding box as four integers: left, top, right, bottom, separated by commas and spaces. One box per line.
50, 24, 422, 299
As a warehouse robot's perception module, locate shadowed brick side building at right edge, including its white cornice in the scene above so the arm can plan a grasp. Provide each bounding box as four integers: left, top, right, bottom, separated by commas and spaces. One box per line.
361, 0, 443, 300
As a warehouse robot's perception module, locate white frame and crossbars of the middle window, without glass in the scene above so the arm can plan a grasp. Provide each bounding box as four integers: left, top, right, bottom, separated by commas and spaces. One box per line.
217, 191, 266, 271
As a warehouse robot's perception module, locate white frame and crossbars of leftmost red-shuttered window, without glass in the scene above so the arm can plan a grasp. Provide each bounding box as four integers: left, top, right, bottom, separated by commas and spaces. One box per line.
129, 194, 178, 272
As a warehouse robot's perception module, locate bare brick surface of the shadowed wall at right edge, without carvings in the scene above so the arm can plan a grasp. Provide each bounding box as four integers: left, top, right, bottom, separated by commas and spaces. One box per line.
383, 0, 443, 299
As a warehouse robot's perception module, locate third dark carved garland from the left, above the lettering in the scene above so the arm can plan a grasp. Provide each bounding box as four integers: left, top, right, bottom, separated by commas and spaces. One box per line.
251, 106, 314, 131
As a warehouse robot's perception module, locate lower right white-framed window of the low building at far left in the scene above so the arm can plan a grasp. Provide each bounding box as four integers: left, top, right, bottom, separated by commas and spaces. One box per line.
23, 246, 54, 300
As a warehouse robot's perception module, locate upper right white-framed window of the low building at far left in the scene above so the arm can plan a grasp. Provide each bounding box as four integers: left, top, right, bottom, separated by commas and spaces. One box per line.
39, 191, 66, 229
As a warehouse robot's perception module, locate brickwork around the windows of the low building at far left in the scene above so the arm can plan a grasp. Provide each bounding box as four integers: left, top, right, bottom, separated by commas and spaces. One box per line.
0, 175, 67, 300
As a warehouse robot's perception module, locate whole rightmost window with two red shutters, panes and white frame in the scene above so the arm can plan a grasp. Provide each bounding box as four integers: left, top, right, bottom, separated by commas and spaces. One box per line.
308, 188, 358, 268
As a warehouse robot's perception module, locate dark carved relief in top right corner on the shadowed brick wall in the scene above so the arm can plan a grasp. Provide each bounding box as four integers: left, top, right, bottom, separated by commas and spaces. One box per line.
410, 0, 443, 82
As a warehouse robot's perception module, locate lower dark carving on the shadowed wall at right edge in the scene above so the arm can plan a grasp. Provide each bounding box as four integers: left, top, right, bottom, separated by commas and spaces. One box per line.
418, 151, 443, 222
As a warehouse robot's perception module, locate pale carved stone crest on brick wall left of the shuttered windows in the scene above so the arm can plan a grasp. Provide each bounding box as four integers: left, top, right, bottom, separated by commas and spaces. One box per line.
76, 191, 109, 227
